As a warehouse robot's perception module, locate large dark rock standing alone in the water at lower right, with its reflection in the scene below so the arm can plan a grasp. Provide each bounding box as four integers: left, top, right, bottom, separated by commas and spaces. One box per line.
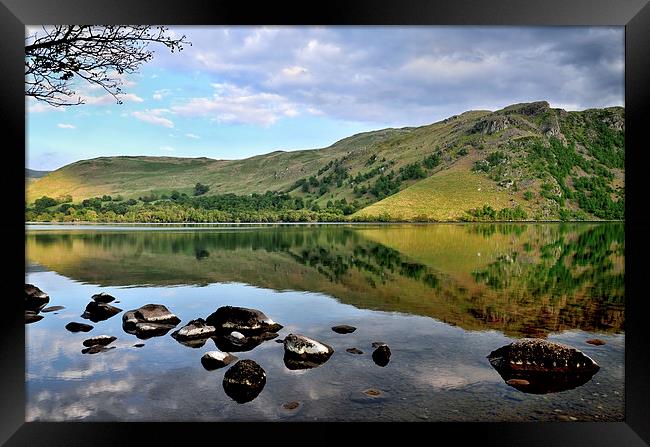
488, 338, 600, 394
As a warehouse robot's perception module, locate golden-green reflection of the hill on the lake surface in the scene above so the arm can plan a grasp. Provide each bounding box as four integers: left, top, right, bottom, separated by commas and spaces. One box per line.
26, 224, 624, 336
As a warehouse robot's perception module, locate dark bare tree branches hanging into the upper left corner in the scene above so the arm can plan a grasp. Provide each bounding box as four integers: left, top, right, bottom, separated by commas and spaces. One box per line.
25, 25, 191, 107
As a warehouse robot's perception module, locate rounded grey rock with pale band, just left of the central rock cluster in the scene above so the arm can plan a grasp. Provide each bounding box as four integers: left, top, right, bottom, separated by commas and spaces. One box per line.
122, 304, 181, 340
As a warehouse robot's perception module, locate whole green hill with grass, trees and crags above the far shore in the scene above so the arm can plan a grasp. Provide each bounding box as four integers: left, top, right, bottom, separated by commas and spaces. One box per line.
28, 102, 625, 221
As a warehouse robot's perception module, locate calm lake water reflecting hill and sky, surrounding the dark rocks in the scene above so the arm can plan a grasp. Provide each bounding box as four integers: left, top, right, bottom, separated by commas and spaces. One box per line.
25, 223, 625, 421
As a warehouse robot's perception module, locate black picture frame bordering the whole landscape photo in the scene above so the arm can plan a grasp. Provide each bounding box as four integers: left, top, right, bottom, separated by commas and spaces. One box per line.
0, 0, 650, 447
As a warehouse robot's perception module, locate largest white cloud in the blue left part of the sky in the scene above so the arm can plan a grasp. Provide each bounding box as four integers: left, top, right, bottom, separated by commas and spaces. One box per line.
171, 83, 298, 126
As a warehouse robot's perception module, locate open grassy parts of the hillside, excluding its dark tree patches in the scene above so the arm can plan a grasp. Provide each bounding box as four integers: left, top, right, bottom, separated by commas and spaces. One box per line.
27, 103, 625, 220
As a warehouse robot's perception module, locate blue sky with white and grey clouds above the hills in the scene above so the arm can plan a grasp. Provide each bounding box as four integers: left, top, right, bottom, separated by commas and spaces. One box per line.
26, 26, 624, 170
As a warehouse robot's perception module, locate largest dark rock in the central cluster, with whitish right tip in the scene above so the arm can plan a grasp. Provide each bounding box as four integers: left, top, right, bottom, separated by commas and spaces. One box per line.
205, 306, 282, 335
